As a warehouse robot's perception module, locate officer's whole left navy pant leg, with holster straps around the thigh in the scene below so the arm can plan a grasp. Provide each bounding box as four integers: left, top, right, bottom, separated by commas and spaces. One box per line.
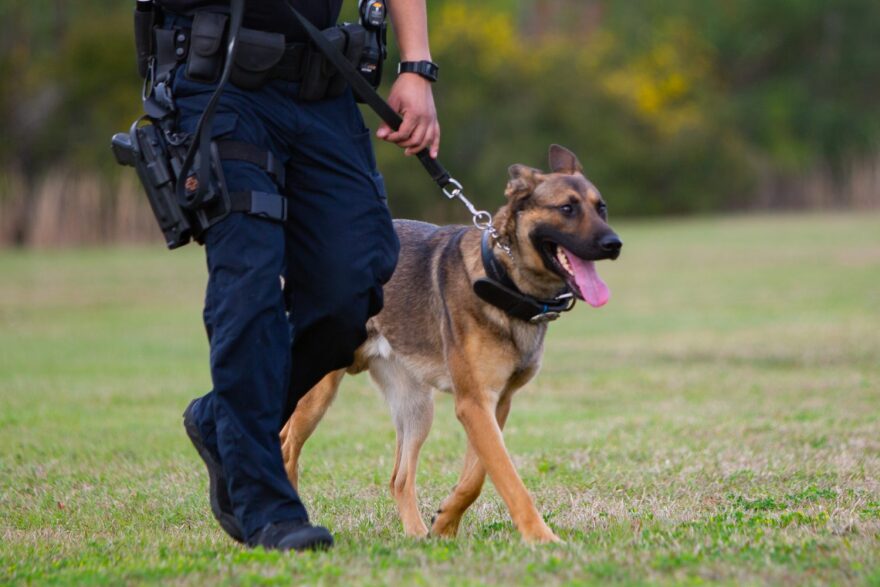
175, 70, 308, 539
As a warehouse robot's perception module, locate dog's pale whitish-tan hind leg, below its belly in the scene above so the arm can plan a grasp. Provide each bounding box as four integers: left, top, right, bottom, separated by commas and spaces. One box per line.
370, 359, 434, 538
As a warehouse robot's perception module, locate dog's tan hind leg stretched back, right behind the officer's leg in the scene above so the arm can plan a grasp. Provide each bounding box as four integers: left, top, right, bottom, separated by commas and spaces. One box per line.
280, 369, 345, 488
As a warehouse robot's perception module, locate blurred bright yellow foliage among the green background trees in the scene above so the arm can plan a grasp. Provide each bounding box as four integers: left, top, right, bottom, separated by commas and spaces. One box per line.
432, 0, 710, 137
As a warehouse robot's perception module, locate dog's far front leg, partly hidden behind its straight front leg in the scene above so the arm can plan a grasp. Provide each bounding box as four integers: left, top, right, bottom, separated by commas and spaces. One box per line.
431, 393, 513, 538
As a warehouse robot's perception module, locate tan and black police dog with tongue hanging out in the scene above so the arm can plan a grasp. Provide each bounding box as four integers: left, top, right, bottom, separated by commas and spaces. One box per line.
281, 145, 621, 543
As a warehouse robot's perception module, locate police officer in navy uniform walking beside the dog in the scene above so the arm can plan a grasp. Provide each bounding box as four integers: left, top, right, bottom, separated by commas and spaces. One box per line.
156, 0, 440, 550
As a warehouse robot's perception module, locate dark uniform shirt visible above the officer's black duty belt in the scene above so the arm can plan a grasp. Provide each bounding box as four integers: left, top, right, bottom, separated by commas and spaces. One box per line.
157, 0, 342, 42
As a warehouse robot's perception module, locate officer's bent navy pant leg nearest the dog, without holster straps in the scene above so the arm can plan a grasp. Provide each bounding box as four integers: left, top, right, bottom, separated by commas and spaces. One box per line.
282, 92, 399, 421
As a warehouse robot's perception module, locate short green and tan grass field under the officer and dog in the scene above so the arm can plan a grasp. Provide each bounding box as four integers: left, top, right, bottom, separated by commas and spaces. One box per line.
0, 214, 880, 585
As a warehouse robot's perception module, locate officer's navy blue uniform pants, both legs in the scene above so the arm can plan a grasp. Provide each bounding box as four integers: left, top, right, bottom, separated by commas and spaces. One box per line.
173, 66, 399, 539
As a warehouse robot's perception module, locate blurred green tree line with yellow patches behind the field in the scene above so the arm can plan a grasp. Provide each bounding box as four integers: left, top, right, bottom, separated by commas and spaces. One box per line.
0, 0, 880, 243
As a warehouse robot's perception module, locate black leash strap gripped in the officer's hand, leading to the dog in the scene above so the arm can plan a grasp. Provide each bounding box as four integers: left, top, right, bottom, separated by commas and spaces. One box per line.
285, 0, 452, 189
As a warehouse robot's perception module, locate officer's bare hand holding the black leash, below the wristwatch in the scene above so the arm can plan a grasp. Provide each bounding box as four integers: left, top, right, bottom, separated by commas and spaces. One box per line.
376, 73, 440, 159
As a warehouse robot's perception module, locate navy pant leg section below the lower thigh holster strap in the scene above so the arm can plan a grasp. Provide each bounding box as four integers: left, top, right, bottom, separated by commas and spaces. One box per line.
201, 210, 308, 538
